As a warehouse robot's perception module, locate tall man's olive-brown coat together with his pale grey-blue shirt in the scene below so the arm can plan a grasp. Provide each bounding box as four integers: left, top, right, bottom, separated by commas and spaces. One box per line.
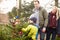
30, 7, 48, 27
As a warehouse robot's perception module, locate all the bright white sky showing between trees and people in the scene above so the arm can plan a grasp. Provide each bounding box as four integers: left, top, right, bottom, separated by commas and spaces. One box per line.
0, 0, 59, 14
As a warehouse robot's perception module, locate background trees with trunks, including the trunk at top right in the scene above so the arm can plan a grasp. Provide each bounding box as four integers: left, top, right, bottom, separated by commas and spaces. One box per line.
9, 0, 58, 18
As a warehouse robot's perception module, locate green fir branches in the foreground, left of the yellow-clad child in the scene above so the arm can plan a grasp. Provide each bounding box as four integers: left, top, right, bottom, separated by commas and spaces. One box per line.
0, 22, 31, 40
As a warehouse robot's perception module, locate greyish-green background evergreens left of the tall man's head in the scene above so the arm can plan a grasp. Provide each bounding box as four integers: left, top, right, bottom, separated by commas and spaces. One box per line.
8, 2, 34, 18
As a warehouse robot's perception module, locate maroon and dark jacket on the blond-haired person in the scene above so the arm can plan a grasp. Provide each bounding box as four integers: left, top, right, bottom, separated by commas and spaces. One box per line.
48, 12, 57, 28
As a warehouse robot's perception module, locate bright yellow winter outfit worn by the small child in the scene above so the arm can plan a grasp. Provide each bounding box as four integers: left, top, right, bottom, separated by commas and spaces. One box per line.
22, 25, 38, 40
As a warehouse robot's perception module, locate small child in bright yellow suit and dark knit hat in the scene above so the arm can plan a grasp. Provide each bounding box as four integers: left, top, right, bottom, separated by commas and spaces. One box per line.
22, 17, 38, 40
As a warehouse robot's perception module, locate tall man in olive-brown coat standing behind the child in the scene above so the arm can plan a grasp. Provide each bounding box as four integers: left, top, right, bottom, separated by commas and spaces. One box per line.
30, 0, 48, 40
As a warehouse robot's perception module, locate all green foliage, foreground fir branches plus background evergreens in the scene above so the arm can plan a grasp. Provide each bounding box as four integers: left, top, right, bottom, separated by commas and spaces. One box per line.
0, 2, 34, 40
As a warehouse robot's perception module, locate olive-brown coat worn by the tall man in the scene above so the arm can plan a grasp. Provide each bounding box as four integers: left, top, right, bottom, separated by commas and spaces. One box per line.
39, 7, 48, 27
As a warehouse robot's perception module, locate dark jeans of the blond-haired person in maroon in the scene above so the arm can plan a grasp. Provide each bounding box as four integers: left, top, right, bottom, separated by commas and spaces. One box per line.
46, 27, 56, 40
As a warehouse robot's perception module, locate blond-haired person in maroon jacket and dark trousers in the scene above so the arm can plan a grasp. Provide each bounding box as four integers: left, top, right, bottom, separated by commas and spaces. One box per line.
46, 6, 59, 40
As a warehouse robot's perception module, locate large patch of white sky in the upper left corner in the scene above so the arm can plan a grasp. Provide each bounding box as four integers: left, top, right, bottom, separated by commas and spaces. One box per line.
0, 0, 16, 14
